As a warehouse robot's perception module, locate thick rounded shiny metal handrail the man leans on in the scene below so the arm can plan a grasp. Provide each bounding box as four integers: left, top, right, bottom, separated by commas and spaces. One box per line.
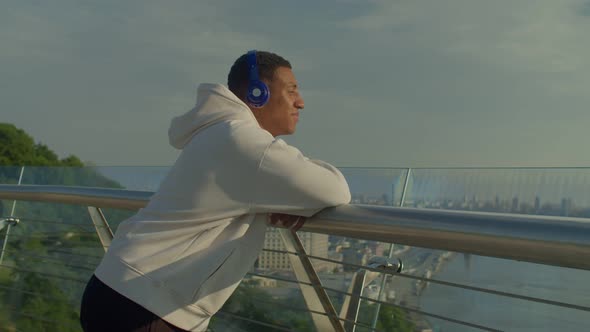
0, 185, 590, 270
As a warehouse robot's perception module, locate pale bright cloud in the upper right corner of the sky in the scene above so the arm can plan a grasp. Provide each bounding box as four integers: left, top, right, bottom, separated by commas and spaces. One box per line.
343, 0, 590, 73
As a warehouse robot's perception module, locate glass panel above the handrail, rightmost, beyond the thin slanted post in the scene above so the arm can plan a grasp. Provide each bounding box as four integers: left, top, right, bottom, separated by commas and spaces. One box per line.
406, 168, 590, 217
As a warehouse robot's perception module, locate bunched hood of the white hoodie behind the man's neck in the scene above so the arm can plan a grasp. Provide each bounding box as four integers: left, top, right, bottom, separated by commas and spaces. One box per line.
168, 84, 256, 150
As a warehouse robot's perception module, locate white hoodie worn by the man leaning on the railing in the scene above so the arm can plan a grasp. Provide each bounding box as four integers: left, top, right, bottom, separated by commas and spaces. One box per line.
95, 84, 350, 331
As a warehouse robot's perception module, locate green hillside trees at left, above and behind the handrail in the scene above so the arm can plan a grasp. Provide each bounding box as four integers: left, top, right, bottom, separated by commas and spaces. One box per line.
0, 123, 130, 331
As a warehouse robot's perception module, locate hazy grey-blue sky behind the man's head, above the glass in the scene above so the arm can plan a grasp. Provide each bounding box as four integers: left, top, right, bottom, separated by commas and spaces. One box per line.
0, 0, 590, 167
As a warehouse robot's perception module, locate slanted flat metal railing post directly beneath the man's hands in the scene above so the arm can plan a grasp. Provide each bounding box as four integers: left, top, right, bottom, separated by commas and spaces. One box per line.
279, 229, 344, 332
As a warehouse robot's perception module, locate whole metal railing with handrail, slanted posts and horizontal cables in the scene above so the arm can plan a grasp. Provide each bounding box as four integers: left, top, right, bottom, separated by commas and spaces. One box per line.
0, 184, 590, 331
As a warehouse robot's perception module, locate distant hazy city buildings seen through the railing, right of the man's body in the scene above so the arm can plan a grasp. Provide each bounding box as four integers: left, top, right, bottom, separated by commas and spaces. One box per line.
255, 171, 590, 331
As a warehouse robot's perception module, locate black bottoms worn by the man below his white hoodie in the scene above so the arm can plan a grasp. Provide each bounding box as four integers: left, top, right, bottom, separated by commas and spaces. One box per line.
80, 275, 187, 332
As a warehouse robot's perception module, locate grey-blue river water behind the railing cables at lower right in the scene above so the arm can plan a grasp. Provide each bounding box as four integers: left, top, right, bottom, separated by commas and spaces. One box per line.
421, 254, 590, 332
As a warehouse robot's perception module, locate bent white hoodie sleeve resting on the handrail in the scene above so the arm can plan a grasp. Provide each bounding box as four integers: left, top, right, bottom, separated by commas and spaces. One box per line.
251, 139, 350, 217
